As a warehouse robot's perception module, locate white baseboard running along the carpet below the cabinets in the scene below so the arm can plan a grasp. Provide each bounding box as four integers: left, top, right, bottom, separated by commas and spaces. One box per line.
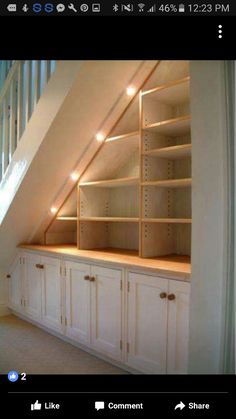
10, 308, 139, 374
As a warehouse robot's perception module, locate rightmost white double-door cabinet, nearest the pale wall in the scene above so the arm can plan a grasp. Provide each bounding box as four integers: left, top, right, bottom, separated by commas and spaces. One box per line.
127, 273, 190, 374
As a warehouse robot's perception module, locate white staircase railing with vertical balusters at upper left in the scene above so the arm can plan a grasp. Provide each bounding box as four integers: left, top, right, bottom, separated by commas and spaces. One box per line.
0, 60, 56, 182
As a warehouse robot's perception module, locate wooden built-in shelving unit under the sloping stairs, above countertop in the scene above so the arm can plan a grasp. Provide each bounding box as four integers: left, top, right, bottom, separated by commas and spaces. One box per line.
46, 62, 192, 261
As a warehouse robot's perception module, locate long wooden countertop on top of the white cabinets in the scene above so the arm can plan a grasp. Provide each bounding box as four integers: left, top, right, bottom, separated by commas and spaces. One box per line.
18, 244, 191, 281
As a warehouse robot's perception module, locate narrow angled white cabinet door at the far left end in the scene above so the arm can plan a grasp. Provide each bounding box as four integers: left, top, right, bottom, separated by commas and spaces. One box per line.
9, 255, 23, 310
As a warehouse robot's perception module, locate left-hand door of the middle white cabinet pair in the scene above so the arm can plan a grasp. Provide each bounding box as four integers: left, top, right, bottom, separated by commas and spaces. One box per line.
65, 262, 90, 345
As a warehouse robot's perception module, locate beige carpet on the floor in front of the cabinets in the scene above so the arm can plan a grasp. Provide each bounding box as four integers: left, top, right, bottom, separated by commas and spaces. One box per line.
0, 315, 126, 374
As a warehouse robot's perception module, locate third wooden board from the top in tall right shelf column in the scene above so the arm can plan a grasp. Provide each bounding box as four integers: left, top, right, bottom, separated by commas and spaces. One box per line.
143, 144, 192, 160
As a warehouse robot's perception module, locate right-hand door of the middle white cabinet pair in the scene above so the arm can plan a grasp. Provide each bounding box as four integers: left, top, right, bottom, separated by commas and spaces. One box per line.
91, 266, 122, 359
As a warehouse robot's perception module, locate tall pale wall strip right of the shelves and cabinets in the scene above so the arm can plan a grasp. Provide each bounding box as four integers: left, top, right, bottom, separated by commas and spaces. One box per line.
189, 61, 227, 374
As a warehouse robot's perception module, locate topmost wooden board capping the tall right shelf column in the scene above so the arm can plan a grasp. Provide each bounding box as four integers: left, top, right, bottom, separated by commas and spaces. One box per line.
142, 77, 190, 105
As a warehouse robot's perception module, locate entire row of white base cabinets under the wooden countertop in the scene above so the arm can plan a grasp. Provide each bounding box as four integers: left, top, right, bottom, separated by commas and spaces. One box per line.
9, 252, 190, 374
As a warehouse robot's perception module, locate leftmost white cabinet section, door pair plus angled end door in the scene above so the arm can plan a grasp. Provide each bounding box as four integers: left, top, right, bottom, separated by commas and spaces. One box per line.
9, 253, 62, 330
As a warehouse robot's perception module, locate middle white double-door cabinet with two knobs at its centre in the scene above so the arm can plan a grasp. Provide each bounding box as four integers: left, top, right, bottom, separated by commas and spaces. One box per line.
65, 262, 122, 359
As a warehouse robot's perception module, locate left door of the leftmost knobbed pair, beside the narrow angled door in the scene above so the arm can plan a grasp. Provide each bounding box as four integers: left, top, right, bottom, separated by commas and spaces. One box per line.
24, 253, 42, 321
